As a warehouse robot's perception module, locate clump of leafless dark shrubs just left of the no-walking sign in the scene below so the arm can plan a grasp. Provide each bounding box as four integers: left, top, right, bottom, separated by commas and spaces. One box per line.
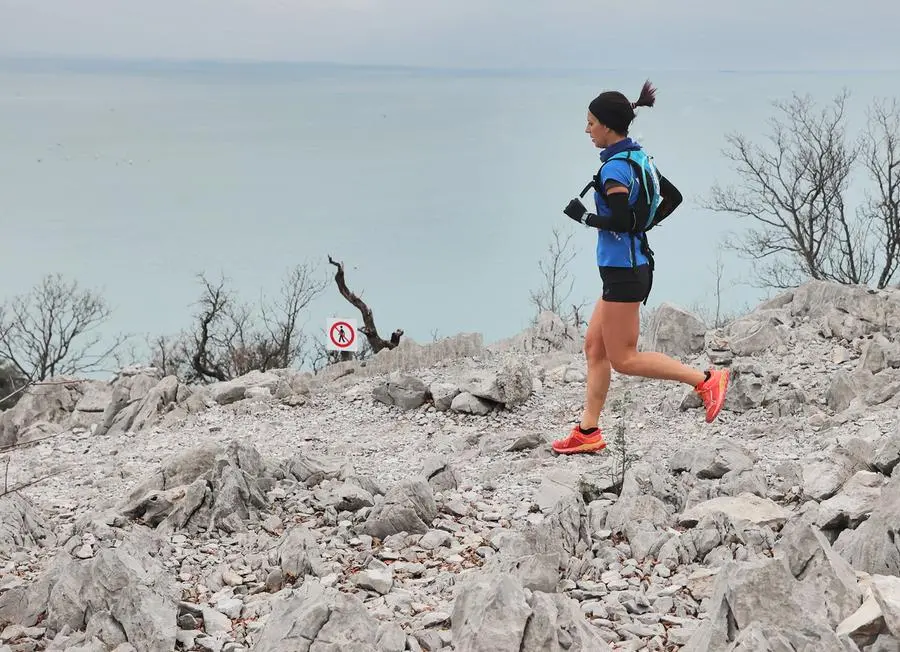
155, 263, 327, 382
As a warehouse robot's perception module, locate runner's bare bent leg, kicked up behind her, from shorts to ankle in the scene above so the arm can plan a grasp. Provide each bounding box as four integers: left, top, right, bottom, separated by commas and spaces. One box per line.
592, 301, 706, 387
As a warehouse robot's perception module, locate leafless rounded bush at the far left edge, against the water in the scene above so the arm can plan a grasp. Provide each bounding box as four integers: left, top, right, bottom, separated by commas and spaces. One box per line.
0, 274, 126, 380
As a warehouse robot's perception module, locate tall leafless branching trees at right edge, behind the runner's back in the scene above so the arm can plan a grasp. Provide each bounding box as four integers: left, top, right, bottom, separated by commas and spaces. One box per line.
706, 91, 898, 288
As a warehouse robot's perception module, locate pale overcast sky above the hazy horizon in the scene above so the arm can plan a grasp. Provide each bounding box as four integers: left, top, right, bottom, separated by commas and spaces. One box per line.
0, 0, 900, 70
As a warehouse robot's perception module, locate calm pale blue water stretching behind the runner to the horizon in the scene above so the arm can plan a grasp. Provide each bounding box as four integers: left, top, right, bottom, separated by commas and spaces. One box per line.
0, 57, 900, 366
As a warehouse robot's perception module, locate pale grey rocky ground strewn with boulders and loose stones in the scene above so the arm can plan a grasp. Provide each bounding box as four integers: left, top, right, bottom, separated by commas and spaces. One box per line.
0, 283, 900, 652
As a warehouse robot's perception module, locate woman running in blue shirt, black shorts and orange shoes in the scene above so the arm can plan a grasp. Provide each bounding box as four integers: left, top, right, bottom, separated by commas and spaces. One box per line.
552, 81, 728, 453
